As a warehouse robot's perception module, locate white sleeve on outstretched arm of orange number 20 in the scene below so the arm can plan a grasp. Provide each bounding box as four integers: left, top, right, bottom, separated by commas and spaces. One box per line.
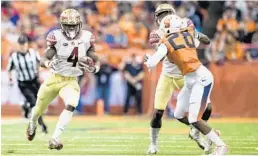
145, 43, 168, 69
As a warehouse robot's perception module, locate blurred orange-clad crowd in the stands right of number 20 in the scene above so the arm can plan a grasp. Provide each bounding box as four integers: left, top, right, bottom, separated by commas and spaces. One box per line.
206, 1, 258, 64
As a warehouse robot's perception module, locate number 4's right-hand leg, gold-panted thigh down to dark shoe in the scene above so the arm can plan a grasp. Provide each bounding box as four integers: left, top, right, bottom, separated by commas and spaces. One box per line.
49, 79, 80, 150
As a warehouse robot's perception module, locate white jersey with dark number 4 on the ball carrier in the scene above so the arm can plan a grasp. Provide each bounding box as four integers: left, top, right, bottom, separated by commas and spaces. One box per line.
46, 29, 95, 77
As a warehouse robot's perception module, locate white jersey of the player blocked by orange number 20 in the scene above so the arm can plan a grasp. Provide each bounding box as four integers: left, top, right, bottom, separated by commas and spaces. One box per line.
157, 18, 199, 78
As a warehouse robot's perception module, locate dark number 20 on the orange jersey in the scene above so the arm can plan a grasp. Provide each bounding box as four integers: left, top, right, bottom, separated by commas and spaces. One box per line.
168, 31, 195, 50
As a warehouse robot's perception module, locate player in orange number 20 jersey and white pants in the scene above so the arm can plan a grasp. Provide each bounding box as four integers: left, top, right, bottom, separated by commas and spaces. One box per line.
145, 15, 228, 155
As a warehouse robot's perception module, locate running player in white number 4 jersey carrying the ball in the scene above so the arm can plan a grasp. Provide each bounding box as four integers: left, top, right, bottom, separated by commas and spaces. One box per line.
27, 9, 99, 150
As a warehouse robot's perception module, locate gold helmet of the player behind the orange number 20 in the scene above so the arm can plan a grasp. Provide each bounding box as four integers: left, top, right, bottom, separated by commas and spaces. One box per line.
154, 3, 176, 25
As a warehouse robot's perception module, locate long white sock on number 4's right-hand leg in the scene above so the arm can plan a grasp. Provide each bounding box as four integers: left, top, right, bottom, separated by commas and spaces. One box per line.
52, 109, 73, 139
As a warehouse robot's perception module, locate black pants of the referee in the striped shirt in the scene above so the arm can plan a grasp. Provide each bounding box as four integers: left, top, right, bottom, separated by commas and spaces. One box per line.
18, 78, 47, 130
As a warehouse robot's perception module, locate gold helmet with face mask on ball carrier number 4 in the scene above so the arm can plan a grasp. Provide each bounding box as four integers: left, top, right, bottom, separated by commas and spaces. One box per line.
60, 9, 82, 39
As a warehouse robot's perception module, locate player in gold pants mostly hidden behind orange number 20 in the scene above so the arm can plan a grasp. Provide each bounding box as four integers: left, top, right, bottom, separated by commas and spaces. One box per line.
146, 4, 211, 154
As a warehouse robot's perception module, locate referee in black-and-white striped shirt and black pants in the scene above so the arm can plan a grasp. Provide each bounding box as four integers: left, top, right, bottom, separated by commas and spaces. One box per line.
7, 35, 47, 133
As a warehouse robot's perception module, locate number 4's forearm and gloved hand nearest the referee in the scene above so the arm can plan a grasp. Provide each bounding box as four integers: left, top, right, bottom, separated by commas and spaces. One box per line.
40, 46, 56, 68
